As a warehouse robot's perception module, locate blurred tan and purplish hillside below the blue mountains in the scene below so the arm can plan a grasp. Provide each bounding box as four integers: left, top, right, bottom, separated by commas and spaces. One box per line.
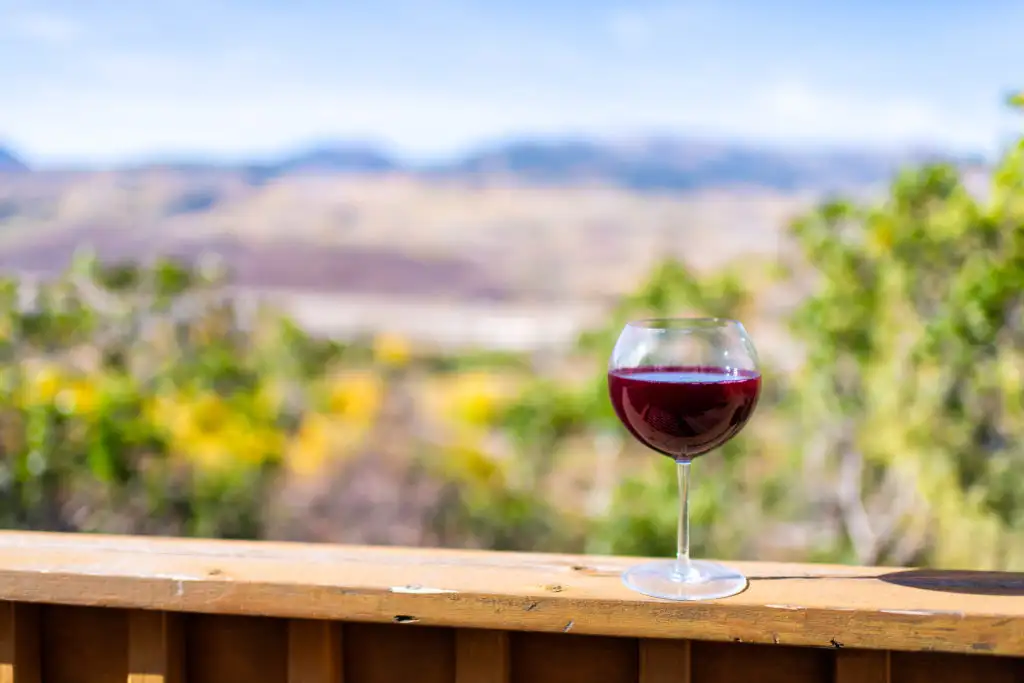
0, 169, 808, 301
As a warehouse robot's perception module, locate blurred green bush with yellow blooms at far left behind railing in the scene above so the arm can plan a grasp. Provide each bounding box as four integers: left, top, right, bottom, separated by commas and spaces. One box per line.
0, 253, 311, 537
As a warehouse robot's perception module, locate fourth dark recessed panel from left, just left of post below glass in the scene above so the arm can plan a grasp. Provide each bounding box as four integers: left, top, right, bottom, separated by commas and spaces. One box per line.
511, 633, 639, 683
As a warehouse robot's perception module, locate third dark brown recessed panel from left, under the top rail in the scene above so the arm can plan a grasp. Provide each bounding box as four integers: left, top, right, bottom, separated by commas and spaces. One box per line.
343, 624, 455, 683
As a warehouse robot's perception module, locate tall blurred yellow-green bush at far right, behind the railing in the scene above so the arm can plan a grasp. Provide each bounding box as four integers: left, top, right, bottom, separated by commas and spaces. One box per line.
788, 136, 1024, 567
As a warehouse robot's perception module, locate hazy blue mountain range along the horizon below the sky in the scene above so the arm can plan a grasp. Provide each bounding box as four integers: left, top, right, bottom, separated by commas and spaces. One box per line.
6, 137, 979, 193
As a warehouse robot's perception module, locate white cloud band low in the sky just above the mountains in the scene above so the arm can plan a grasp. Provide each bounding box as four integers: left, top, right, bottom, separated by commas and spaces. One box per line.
6, 78, 997, 162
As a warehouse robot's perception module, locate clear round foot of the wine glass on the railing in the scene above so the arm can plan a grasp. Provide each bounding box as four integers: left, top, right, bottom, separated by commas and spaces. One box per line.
623, 560, 748, 600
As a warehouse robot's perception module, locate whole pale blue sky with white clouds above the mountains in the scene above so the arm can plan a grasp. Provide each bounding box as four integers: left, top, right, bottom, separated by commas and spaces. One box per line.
0, 0, 1024, 164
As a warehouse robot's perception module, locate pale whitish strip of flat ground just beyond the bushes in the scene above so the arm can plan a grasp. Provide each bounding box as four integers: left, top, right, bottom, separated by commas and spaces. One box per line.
6, 270, 604, 352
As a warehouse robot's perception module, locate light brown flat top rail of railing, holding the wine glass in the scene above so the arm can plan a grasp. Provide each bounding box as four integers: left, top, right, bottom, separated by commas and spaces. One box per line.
0, 531, 1024, 655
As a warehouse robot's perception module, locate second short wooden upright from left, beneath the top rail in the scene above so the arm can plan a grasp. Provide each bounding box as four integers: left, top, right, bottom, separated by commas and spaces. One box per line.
128, 609, 184, 683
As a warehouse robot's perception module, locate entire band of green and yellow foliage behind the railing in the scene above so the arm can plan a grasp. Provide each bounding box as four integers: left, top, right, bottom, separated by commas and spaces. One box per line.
0, 100, 1024, 569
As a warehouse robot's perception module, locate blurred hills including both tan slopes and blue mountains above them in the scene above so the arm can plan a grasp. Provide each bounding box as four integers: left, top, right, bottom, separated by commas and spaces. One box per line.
0, 138, 974, 313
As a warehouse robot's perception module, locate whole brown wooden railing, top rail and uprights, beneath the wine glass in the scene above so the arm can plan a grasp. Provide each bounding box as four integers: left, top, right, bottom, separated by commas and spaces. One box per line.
0, 532, 1024, 683
